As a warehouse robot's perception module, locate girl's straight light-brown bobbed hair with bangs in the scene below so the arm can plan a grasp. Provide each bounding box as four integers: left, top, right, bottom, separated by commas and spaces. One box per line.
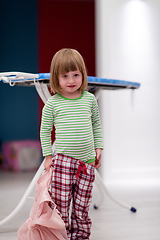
50, 48, 87, 93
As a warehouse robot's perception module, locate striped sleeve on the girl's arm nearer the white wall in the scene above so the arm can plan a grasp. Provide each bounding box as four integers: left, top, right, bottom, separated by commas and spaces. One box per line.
92, 97, 103, 149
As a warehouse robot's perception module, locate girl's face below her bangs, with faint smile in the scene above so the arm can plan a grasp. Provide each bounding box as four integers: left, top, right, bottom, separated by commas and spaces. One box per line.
59, 70, 82, 98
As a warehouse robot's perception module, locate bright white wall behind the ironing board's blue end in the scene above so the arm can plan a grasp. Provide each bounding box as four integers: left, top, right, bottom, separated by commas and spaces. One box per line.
96, 0, 160, 187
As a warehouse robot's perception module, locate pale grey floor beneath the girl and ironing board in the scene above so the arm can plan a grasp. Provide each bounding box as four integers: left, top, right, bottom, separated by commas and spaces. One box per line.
0, 172, 160, 240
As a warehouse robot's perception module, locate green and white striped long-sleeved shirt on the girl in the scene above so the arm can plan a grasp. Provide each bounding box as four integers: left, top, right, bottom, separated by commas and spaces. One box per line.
40, 91, 103, 162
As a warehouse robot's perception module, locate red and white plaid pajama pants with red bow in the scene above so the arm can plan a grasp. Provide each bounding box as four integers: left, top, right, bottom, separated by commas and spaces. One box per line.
51, 153, 95, 240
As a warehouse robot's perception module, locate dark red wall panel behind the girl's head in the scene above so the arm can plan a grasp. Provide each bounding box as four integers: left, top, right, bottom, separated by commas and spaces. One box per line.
38, 0, 95, 142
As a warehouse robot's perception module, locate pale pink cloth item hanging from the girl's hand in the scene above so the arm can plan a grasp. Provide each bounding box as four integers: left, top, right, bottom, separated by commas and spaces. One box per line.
17, 168, 68, 240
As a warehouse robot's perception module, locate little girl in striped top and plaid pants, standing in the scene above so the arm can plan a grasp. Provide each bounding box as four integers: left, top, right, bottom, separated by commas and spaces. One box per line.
40, 49, 103, 240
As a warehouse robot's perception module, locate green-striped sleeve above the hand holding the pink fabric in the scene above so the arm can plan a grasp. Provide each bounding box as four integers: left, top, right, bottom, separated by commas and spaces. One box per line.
40, 100, 54, 156
